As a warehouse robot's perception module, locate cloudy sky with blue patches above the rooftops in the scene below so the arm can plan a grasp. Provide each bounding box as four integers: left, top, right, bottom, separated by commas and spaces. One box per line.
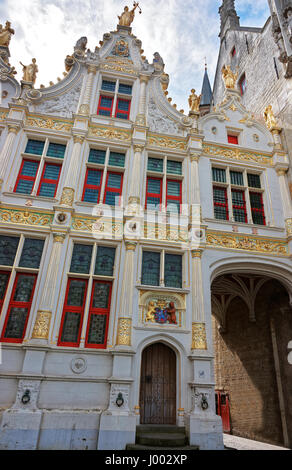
0, 0, 269, 110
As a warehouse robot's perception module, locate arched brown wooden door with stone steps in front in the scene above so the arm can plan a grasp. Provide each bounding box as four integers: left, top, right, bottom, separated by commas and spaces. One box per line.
140, 343, 176, 425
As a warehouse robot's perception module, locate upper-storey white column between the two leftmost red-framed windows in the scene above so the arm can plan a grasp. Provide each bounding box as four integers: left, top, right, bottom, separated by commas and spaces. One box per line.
60, 135, 84, 207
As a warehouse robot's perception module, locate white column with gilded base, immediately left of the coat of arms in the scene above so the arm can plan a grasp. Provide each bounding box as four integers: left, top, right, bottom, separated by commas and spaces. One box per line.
116, 241, 137, 346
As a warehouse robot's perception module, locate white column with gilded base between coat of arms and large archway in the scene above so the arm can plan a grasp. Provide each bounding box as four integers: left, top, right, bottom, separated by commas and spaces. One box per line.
191, 249, 208, 349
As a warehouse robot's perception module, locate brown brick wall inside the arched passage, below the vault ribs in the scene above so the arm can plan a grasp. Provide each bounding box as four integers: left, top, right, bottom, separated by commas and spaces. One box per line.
213, 281, 292, 445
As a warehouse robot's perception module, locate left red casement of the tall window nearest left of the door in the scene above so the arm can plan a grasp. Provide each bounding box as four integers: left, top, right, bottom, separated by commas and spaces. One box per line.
58, 278, 88, 347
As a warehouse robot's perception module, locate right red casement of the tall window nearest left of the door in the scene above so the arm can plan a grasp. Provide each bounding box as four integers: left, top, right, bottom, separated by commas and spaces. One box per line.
85, 281, 112, 349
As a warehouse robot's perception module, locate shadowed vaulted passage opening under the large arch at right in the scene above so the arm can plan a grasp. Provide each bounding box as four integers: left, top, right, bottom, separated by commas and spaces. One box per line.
212, 270, 292, 447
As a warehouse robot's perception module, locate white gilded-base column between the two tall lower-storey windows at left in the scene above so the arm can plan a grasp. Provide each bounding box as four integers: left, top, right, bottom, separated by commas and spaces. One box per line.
32, 233, 66, 342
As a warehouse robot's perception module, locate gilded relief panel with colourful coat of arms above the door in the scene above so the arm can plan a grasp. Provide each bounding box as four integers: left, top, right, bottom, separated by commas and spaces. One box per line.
139, 291, 186, 329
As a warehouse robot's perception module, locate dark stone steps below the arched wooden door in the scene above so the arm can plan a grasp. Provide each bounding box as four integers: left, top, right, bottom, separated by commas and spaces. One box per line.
136, 432, 188, 448
